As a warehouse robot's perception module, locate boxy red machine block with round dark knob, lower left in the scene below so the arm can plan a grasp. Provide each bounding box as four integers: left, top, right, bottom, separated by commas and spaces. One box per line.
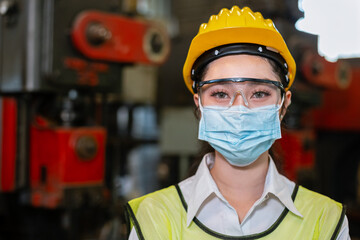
30, 126, 106, 208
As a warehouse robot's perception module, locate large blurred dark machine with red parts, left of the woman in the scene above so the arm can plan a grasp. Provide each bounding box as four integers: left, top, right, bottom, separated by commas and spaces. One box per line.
0, 0, 170, 240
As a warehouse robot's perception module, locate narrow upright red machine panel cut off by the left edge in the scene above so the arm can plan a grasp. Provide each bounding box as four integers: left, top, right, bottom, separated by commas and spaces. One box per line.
0, 97, 17, 192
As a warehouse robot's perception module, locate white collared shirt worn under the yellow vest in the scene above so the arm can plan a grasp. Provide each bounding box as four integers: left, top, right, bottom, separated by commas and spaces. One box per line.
129, 153, 350, 240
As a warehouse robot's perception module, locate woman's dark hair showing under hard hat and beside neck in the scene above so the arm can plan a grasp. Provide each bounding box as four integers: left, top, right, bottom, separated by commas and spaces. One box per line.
188, 57, 284, 176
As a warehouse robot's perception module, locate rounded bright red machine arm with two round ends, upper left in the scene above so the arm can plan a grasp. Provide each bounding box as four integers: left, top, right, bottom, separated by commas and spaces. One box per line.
72, 11, 170, 64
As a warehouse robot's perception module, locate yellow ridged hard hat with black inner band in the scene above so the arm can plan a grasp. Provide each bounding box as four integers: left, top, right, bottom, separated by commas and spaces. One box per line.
183, 6, 296, 93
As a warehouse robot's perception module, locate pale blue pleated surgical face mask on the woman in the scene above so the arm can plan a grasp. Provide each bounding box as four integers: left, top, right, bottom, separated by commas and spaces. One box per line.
198, 99, 284, 167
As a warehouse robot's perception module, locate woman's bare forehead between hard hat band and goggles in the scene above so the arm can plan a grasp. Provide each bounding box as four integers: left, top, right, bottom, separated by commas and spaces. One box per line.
204, 54, 279, 81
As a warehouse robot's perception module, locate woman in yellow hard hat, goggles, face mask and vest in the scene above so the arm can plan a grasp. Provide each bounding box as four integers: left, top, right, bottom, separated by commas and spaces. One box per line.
127, 6, 349, 239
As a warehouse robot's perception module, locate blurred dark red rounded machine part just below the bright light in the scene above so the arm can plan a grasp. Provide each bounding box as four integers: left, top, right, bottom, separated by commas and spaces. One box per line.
301, 50, 352, 90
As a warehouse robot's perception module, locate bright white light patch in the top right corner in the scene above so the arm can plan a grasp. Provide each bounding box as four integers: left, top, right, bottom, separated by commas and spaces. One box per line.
295, 0, 360, 61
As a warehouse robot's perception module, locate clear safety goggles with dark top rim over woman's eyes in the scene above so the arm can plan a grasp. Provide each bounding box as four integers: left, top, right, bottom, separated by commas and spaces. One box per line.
198, 78, 285, 109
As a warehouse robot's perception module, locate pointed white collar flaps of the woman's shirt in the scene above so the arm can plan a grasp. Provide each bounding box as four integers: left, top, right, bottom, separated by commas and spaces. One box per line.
186, 153, 302, 226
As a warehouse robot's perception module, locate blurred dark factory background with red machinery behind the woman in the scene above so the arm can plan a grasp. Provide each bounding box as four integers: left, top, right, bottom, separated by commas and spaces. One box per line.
0, 0, 360, 240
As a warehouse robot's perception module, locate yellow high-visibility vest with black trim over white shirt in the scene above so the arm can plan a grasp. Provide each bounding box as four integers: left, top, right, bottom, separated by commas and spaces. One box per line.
126, 185, 345, 240
